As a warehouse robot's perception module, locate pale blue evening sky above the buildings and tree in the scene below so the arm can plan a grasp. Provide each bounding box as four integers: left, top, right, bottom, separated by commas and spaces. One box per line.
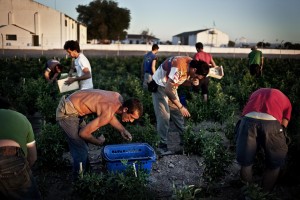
35, 0, 300, 43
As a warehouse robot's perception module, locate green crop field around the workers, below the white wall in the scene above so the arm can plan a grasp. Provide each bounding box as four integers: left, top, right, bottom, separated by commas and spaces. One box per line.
0, 55, 300, 199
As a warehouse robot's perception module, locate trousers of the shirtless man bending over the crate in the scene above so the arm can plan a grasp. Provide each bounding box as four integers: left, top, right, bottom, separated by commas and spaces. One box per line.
58, 116, 90, 180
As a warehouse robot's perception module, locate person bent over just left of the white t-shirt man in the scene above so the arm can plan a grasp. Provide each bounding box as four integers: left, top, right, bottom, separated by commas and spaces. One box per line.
44, 59, 63, 83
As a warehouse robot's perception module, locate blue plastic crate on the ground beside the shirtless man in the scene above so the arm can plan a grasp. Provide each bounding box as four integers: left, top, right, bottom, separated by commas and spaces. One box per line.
102, 143, 156, 173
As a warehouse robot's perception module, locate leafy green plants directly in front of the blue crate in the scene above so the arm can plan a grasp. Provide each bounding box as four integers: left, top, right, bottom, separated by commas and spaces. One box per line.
74, 166, 155, 200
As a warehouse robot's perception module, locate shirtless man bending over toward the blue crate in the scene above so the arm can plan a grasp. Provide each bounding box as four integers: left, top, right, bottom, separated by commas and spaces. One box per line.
56, 89, 143, 180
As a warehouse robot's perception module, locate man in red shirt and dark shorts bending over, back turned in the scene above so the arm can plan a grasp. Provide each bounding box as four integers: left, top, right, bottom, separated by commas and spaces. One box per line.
236, 88, 292, 192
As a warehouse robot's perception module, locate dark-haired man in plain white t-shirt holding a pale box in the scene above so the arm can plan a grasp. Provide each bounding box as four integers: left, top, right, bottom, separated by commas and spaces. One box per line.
64, 40, 94, 90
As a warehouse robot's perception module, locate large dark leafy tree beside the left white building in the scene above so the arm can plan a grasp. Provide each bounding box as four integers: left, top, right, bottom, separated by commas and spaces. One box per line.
76, 0, 131, 40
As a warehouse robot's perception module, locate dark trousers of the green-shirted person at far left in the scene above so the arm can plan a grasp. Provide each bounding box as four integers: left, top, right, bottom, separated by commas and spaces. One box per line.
0, 155, 41, 200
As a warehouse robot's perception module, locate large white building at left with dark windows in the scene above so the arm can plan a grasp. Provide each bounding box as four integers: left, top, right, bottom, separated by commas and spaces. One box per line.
0, 0, 87, 49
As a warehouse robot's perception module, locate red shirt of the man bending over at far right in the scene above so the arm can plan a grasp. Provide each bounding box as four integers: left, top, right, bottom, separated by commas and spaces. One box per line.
242, 88, 292, 123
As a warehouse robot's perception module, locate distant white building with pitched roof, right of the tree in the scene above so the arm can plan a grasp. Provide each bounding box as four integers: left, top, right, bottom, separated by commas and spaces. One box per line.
172, 28, 229, 47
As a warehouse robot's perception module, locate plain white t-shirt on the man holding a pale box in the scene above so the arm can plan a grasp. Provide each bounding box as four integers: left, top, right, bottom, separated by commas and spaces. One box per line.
74, 53, 94, 90
